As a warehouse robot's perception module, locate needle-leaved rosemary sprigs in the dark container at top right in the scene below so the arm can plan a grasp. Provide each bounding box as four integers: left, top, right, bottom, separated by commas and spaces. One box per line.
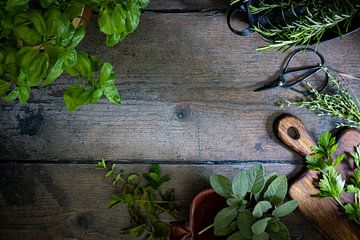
249, 0, 359, 51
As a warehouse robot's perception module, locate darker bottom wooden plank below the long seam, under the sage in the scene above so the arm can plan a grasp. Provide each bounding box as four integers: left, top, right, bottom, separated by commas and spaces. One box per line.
0, 164, 322, 240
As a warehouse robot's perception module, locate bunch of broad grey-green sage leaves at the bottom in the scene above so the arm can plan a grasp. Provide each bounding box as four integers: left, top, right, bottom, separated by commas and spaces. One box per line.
210, 165, 298, 240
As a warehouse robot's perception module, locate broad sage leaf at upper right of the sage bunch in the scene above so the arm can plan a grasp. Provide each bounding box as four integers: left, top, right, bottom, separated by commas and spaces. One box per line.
264, 176, 288, 206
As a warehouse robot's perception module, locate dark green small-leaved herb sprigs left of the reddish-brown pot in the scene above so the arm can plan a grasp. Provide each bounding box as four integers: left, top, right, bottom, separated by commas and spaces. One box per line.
97, 160, 181, 240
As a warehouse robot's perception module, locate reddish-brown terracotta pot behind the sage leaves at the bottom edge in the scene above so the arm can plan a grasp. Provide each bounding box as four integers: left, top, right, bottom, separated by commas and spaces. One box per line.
170, 189, 226, 240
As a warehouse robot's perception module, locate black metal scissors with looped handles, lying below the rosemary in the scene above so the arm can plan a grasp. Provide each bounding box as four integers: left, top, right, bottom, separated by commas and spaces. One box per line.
254, 48, 329, 94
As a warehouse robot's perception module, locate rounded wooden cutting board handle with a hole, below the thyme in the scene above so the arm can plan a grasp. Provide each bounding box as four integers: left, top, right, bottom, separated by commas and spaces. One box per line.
274, 114, 316, 156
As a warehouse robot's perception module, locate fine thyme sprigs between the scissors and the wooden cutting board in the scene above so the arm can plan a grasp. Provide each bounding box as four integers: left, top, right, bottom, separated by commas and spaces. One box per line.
278, 66, 360, 128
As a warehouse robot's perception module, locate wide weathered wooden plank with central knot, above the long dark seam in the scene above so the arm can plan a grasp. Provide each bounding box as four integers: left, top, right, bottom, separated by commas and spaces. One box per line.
0, 13, 360, 161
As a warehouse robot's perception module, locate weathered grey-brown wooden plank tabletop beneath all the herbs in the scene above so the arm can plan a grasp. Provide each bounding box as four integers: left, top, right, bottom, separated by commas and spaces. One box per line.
0, 0, 360, 240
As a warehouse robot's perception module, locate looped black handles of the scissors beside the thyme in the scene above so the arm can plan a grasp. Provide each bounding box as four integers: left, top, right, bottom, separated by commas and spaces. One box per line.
280, 48, 329, 93
